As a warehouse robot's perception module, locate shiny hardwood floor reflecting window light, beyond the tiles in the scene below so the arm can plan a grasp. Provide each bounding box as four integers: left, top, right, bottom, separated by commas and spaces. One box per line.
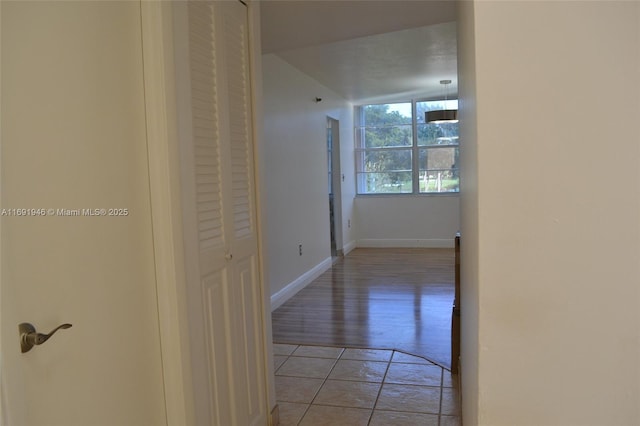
272, 248, 454, 368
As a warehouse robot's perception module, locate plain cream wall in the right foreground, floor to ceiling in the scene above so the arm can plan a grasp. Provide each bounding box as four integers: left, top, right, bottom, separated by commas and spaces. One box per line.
459, 1, 640, 426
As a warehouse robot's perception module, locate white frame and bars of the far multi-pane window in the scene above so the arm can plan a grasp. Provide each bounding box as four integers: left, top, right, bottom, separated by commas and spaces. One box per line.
354, 98, 460, 197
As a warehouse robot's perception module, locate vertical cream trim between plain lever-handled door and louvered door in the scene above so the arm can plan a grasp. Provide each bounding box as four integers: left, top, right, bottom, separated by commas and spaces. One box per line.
141, 1, 195, 426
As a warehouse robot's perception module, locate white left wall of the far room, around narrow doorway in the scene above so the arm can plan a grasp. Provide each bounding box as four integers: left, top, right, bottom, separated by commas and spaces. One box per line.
261, 54, 354, 301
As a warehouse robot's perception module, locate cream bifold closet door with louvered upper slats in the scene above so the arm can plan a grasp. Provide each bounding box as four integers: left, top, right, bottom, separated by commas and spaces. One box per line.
174, 1, 267, 425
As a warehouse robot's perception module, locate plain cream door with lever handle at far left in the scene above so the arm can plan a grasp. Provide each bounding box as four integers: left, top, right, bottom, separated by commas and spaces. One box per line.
0, 1, 166, 426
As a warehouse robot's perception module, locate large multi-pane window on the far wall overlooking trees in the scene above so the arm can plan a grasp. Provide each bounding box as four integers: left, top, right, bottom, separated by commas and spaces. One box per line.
355, 100, 460, 194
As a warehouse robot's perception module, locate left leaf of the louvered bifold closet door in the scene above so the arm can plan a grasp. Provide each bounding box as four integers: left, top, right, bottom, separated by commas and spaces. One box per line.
179, 1, 234, 425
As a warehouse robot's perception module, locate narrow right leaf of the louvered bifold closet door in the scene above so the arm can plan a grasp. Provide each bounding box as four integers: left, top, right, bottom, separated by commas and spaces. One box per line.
216, 1, 267, 425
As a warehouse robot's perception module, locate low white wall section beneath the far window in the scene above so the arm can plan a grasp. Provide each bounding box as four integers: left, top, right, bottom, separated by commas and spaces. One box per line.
355, 194, 460, 247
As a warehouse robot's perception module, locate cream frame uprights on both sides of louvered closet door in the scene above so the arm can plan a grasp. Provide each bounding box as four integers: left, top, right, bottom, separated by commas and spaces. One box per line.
141, 1, 275, 426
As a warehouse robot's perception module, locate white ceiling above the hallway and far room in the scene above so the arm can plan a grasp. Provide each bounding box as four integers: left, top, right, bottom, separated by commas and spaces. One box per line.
261, 0, 457, 102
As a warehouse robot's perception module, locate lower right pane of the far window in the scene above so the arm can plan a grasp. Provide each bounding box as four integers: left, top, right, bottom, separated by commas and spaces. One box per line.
419, 147, 460, 192
